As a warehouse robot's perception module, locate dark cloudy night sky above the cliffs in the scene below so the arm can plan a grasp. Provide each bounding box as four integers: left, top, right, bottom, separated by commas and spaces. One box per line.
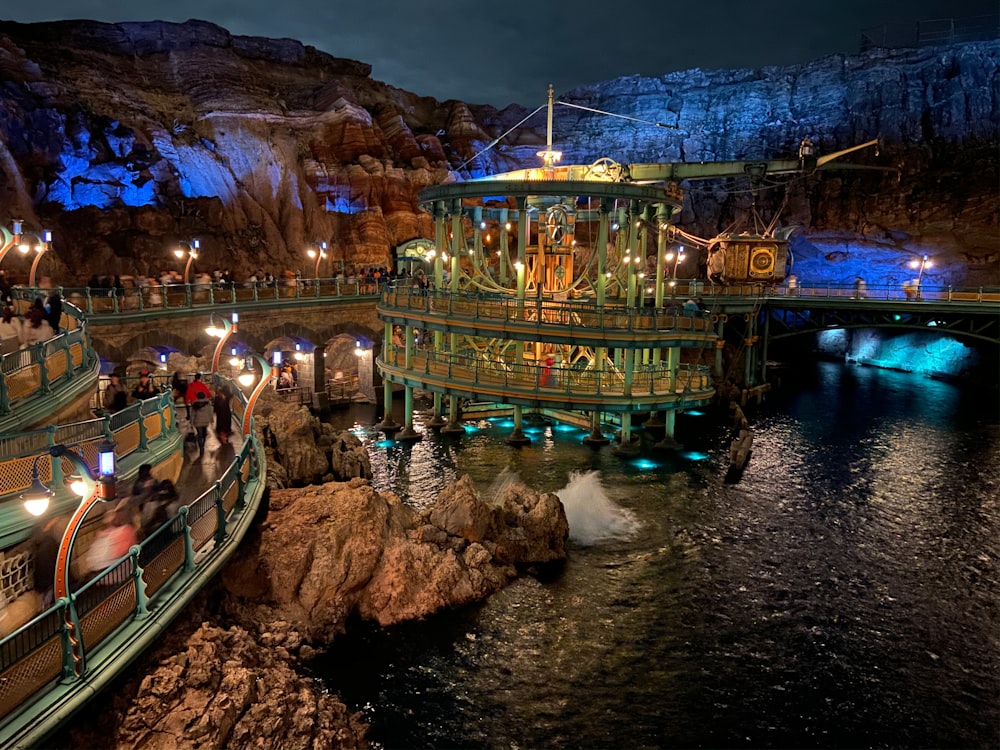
0, 0, 1000, 108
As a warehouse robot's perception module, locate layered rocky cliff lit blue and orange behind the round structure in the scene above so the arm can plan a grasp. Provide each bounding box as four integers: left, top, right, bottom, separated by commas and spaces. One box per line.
0, 21, 1000, 284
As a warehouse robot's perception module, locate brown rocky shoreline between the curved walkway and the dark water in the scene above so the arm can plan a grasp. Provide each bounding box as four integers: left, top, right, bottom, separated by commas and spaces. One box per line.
54, 396, 569, 750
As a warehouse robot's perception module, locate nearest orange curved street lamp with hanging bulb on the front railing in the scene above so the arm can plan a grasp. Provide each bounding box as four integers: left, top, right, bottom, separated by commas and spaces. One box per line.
21, 440, 117, 676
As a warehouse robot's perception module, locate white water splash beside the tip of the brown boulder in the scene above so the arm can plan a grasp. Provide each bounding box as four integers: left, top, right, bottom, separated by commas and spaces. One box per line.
556, 471, 640, 545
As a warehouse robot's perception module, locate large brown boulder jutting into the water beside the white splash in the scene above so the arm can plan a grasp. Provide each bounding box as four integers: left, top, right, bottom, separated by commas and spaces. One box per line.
223, 477, 569, 642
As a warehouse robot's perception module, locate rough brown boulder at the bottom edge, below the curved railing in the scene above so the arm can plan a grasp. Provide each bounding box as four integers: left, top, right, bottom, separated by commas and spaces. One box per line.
63, 623, 368, 750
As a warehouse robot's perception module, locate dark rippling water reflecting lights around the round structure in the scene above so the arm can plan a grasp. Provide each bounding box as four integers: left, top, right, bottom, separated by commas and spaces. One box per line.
314, 363, 1000, 749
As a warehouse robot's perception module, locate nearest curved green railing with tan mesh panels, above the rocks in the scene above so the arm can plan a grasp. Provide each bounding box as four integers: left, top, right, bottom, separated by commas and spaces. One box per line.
0, 388, 265, 747
